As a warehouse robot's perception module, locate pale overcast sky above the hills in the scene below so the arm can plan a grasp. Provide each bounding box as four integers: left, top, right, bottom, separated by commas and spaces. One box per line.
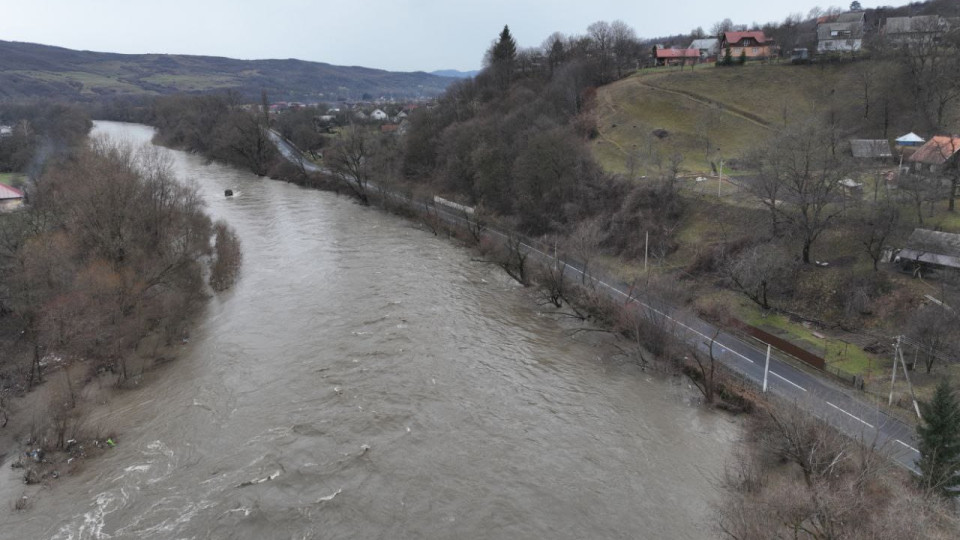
0, 0, 906, 71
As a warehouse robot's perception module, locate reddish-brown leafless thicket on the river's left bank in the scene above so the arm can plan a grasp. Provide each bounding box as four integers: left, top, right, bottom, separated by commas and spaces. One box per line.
0, 140, 239, 388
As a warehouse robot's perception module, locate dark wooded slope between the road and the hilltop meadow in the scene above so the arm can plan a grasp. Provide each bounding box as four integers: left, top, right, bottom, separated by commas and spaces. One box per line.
400, 22, 682, 255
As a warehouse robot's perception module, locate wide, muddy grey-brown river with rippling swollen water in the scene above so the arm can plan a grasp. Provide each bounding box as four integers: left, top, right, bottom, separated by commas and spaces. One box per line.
0, 122, 740, 539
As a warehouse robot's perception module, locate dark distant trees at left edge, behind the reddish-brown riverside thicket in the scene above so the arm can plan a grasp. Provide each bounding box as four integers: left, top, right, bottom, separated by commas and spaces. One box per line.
0, 101, 93, 172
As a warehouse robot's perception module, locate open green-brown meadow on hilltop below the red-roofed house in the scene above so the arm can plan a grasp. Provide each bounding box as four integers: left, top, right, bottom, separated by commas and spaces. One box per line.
594, 61, 915, 173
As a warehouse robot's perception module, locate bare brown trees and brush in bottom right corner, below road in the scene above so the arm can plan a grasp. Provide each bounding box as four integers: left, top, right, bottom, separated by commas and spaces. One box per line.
717, 401, 957, 540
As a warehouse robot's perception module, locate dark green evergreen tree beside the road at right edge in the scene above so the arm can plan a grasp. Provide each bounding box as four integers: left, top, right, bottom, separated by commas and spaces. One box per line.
917, 379, 960, 496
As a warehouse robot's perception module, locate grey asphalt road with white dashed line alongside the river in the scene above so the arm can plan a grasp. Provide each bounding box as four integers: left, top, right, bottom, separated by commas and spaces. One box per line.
270, 131, 920, 474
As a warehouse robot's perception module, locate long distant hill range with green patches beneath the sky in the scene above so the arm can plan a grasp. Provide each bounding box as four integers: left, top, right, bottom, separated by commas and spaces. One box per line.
0, 41, 460, 102
